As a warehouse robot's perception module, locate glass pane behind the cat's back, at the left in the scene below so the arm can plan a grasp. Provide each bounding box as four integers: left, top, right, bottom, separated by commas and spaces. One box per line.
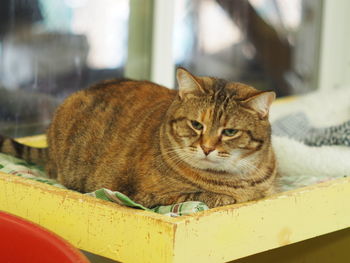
0, 0, 129, 137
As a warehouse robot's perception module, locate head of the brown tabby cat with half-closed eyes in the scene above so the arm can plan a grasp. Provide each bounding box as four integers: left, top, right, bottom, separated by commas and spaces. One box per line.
166, 68, 275, 173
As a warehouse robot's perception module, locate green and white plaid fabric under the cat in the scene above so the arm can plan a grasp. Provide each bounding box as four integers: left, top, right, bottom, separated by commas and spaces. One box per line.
0, 153, 209, 217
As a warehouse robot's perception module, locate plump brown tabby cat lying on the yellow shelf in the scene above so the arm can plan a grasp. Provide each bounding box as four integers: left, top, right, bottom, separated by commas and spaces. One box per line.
0, 68, 276, 208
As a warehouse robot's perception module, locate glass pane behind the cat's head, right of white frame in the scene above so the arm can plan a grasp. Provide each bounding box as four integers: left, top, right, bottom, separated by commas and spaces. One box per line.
174, 0, 321, 96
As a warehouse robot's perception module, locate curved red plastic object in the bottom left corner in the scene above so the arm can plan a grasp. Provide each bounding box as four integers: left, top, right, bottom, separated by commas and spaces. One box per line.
0, 211, 89, 263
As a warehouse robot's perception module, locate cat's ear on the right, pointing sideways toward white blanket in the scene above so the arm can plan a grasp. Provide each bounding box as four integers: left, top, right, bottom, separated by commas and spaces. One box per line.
243, 91, 276, 119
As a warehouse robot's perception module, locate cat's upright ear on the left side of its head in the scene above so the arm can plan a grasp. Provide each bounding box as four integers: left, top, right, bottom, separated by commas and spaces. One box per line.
176, 68, 204, 98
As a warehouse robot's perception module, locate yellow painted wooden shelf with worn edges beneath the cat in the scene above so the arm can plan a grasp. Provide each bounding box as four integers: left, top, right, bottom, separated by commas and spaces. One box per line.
0, 136, 350, 263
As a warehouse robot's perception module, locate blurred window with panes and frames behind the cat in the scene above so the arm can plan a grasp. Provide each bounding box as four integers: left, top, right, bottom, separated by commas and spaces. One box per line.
0, 0, 350, 137
